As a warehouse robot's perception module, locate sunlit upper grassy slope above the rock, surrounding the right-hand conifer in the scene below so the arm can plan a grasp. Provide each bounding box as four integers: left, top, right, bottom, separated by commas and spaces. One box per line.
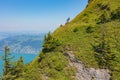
53, 0, 120, 80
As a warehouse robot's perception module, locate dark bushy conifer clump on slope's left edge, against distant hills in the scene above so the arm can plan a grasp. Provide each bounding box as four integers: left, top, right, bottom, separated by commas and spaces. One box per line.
42, 32, 60, 52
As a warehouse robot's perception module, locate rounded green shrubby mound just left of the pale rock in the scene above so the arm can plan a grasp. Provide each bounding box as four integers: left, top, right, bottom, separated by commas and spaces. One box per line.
39, 52, 75, 80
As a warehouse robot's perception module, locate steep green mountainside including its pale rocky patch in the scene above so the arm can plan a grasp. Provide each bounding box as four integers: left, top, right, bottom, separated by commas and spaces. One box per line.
3, 0, 120, 80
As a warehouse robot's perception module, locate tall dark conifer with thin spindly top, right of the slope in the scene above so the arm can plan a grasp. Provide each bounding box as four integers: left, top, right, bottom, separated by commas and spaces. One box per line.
93, 26, 116, 69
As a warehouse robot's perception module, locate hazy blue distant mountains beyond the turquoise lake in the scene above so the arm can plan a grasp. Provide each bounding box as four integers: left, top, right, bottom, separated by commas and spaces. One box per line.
0, 33, 44, 54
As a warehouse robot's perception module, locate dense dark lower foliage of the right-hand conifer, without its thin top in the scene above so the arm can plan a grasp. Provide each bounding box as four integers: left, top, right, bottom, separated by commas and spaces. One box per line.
94, 44, 115, 69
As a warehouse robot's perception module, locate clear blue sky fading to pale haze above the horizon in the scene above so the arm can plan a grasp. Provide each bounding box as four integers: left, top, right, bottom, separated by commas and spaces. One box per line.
0, 0, 88, 32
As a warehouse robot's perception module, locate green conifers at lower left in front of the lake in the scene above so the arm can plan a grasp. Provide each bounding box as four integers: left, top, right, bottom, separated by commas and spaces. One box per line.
1, 46, 24, 80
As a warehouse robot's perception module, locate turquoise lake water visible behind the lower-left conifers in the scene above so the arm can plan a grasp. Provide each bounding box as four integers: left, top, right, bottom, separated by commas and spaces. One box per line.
0, 52, 37, 72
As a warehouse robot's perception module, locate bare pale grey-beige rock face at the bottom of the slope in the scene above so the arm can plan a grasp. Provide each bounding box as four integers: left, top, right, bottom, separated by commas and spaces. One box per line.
65, 51, 110, 80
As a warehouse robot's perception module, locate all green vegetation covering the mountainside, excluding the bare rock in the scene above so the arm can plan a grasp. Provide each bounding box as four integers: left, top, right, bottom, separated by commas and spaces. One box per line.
1, 0, 120, 80
